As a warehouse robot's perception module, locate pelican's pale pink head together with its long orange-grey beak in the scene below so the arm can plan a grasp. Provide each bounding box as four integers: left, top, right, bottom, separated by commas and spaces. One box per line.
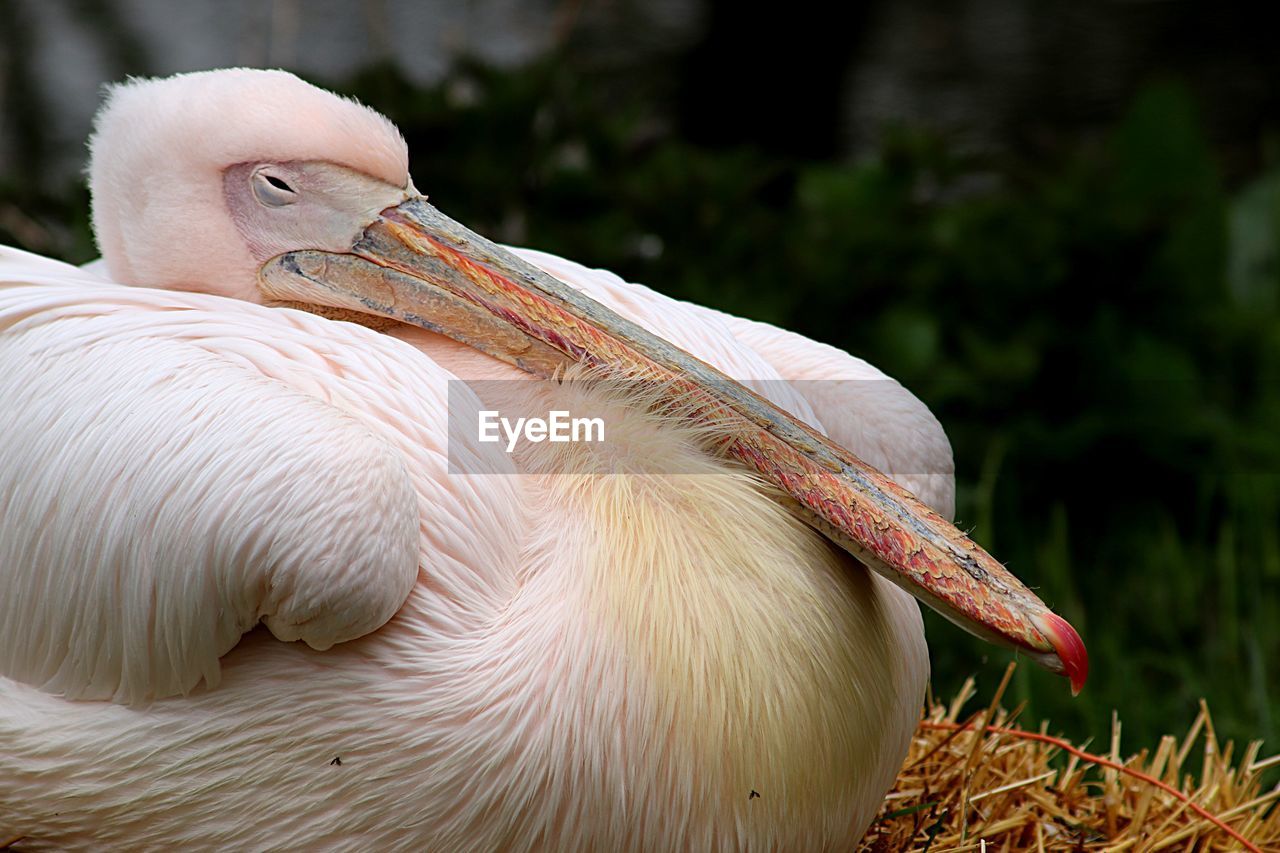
90, 69, 1088, 690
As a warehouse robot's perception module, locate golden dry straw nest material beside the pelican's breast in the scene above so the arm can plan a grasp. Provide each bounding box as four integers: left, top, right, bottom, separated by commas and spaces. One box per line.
860, 665, 1280, 853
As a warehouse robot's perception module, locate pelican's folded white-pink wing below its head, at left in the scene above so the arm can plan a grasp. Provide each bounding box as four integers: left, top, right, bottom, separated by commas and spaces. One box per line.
0, 249, 420, 702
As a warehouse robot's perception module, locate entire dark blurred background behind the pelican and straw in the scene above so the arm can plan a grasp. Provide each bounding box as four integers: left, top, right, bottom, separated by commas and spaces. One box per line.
0, 0, 1280, 751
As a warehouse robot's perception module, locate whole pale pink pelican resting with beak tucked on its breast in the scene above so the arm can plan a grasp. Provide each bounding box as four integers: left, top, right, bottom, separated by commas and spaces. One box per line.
0, 69, 1087, 850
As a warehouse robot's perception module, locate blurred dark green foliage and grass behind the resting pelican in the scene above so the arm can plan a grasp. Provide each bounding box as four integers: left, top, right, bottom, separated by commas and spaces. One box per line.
0, 59, 1280, 748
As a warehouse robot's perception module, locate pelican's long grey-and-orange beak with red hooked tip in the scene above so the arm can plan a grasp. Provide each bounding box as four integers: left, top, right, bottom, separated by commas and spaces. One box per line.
259, 197, 1088, 693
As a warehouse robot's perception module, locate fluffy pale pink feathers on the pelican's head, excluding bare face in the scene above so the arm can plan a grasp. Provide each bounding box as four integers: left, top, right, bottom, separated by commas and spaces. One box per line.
88, 69, 410, 301
